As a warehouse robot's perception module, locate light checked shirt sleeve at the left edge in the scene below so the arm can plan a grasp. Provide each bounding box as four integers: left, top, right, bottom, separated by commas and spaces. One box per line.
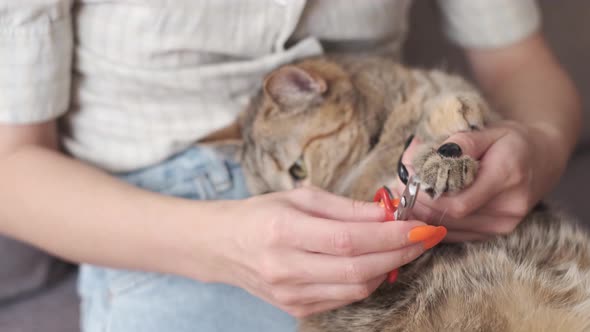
0, 0, 73, 124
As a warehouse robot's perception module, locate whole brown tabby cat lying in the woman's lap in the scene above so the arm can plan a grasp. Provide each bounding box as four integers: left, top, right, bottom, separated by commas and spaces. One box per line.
236, 57, 590, 332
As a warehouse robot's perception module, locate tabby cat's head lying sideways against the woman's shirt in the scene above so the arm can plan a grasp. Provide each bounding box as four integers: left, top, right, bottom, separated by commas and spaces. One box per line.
241, 59, 369, 193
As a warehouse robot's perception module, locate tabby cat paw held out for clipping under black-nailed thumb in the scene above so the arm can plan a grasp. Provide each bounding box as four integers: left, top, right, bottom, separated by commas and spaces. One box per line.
412, 143, 478, 199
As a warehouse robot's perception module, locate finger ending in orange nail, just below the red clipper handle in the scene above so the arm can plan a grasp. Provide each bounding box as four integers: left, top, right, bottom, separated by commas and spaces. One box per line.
289, 219, 425, 256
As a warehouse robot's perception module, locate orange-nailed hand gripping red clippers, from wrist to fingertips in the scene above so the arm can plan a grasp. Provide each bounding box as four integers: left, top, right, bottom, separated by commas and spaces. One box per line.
197, 188, 441, 317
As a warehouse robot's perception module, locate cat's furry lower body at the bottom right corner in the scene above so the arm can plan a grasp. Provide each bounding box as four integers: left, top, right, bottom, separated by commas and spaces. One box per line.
300, 207, 590, 332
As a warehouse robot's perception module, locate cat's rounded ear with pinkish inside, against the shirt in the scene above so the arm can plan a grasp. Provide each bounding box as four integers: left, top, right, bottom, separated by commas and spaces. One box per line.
264, 65, 327, 107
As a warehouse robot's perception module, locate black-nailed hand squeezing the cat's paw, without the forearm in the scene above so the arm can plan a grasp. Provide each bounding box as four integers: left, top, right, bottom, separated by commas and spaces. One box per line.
398, 121, 568, 242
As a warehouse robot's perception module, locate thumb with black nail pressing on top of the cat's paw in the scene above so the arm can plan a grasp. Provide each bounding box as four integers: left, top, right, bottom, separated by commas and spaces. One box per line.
439, 128, 507, 160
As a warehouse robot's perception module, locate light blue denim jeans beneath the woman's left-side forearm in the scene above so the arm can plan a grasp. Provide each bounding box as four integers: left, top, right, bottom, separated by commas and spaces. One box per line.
78, 146, 296, 332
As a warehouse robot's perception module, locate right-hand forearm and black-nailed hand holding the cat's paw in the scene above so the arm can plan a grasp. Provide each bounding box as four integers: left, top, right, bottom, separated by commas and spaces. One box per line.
412, 32, 582, 241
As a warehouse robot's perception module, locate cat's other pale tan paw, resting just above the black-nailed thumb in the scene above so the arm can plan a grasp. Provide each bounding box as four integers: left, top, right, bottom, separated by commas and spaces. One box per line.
416, 93, 489, 142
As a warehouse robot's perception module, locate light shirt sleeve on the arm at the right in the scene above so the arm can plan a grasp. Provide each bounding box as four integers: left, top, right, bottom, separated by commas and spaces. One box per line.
438, 0, 541, 48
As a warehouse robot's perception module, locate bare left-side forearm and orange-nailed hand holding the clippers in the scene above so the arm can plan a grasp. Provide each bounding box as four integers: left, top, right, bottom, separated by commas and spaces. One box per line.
0, 123, 440, 316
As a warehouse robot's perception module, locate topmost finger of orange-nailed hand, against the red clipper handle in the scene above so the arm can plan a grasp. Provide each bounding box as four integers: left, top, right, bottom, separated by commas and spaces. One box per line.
293, 187, 385, 222
